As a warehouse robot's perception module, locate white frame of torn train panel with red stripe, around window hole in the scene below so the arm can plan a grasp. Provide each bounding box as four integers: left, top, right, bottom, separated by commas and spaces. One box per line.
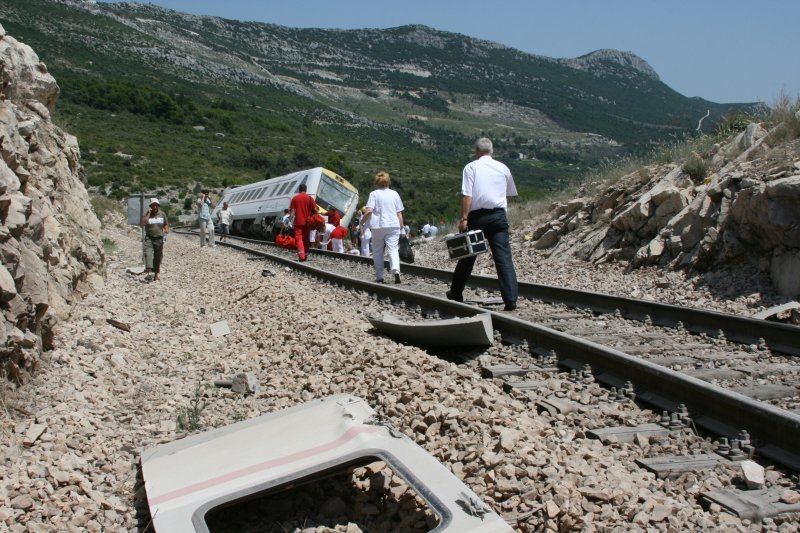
141, 394, 511, 533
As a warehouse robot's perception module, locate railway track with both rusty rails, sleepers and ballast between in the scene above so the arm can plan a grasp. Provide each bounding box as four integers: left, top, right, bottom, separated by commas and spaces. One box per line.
175, 230, 800, 472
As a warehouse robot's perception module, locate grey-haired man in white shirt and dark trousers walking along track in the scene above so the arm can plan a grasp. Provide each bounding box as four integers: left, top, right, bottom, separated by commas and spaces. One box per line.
447, 137, 517, 311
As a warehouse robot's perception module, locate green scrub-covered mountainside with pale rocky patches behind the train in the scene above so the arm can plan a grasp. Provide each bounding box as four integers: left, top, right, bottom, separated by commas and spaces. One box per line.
2, 0, 753, 221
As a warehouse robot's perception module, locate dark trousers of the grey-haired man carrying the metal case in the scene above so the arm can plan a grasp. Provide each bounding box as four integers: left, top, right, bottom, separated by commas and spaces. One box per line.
450, 208, 518, 304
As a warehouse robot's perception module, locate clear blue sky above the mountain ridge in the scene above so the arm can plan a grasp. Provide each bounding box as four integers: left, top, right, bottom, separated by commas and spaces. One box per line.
103, 0, 800, 104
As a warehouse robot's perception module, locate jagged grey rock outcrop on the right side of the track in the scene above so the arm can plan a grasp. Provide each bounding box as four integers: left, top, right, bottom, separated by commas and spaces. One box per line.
524, 119, 800, 298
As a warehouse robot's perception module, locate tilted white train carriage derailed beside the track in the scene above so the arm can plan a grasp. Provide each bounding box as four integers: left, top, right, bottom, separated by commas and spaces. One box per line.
212, 167, 358, 240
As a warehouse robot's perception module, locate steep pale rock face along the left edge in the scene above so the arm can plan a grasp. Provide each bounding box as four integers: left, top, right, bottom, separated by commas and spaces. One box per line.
0, 26, 105, 381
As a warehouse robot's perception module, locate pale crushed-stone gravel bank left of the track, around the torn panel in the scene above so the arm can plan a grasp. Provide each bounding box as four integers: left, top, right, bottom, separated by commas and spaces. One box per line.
7, 227, 797, 531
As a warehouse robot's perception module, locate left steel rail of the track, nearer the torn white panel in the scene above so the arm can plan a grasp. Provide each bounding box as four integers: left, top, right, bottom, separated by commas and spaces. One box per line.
216, 239, 800, 472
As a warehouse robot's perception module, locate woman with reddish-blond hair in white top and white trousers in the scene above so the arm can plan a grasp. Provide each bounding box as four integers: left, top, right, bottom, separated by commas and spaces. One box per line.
363, 172, 403, 283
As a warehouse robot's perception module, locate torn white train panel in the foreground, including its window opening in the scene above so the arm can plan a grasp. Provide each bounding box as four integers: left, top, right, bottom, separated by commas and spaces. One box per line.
141, 394, 511, 533
